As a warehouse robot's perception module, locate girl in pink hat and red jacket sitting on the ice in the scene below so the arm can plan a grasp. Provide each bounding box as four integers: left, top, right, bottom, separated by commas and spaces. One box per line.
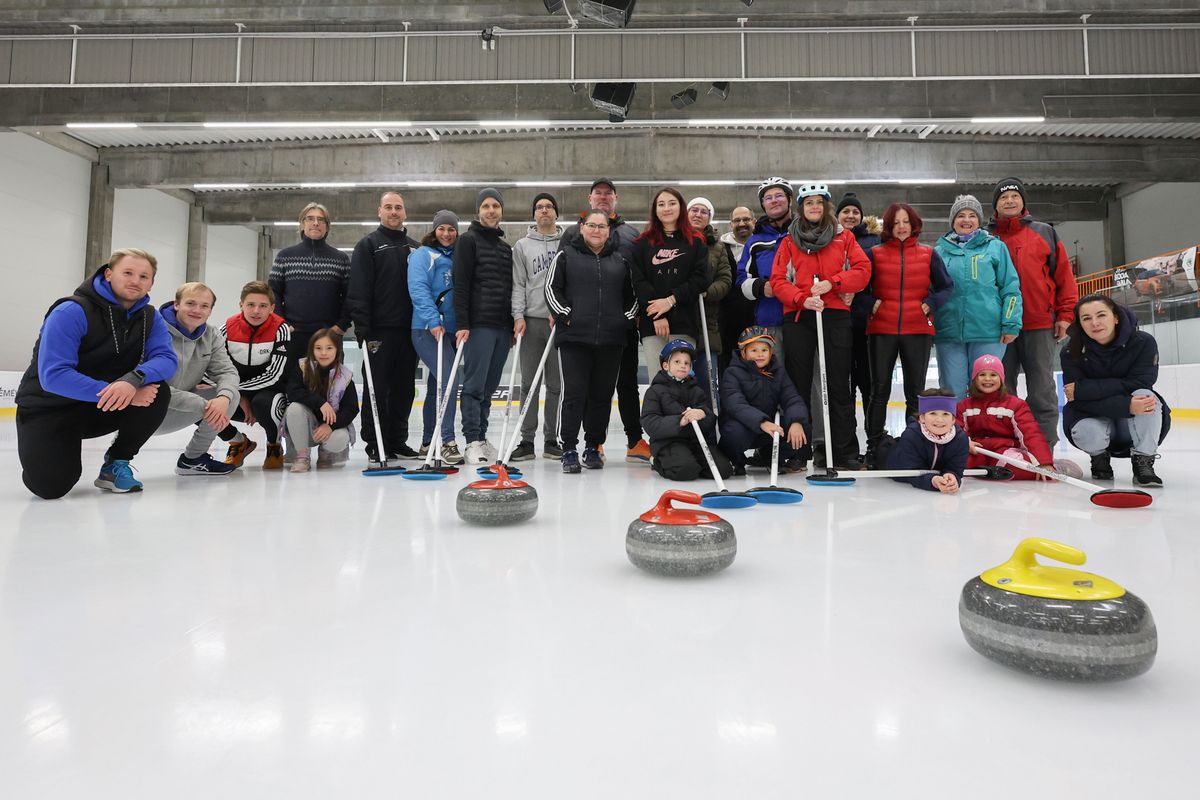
958, 355, 1054, 481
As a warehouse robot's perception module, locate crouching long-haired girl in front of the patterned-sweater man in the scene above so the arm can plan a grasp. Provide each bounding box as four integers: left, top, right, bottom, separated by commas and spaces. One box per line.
283, 327, 359, 473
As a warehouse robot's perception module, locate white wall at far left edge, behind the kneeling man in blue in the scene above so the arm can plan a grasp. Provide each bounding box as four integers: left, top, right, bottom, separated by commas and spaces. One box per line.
0, 133, 91, 371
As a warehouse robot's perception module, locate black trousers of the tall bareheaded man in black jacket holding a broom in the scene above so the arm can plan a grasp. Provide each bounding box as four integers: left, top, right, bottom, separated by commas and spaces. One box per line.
359, 327, 418, 456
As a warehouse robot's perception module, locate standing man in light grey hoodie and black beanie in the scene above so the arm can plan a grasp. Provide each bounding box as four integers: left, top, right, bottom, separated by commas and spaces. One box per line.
510, 192, 563, 461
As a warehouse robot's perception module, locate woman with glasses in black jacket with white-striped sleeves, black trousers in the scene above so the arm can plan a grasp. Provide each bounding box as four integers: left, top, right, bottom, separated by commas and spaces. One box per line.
546, 209, 637, 474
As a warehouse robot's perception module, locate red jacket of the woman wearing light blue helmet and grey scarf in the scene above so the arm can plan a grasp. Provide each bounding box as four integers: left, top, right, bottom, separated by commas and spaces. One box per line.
770, 229, 871, 320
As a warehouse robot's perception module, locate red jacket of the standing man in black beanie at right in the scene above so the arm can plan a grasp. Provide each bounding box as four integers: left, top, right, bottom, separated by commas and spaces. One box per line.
989, 211, 1079, 331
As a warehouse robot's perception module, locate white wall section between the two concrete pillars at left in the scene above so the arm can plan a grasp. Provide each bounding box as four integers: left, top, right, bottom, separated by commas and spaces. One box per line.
113, 188, 188, 306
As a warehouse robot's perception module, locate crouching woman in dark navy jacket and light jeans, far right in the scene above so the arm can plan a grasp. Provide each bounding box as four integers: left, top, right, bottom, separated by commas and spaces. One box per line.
1061, 294, 1171, 487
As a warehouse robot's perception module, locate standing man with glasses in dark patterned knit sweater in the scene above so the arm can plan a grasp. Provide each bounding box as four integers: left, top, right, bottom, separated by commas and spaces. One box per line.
268, 203, 350, 362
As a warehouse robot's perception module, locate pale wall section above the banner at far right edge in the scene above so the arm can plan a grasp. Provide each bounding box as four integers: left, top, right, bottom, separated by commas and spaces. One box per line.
1110, 184, 1200, 266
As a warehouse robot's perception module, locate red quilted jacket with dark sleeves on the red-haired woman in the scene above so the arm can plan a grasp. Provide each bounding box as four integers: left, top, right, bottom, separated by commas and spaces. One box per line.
865, 236, 954, 336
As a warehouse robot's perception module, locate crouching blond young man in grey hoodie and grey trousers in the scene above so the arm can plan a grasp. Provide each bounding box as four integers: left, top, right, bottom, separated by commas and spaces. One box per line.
155, 283, 239, 475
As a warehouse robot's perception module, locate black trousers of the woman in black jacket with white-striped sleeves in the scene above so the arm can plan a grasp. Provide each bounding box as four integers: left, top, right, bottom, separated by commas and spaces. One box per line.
558, 342, 624, 451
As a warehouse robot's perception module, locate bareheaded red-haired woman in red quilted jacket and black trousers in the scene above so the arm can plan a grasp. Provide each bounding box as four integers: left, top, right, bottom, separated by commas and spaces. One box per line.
866, 203, 954, 469
